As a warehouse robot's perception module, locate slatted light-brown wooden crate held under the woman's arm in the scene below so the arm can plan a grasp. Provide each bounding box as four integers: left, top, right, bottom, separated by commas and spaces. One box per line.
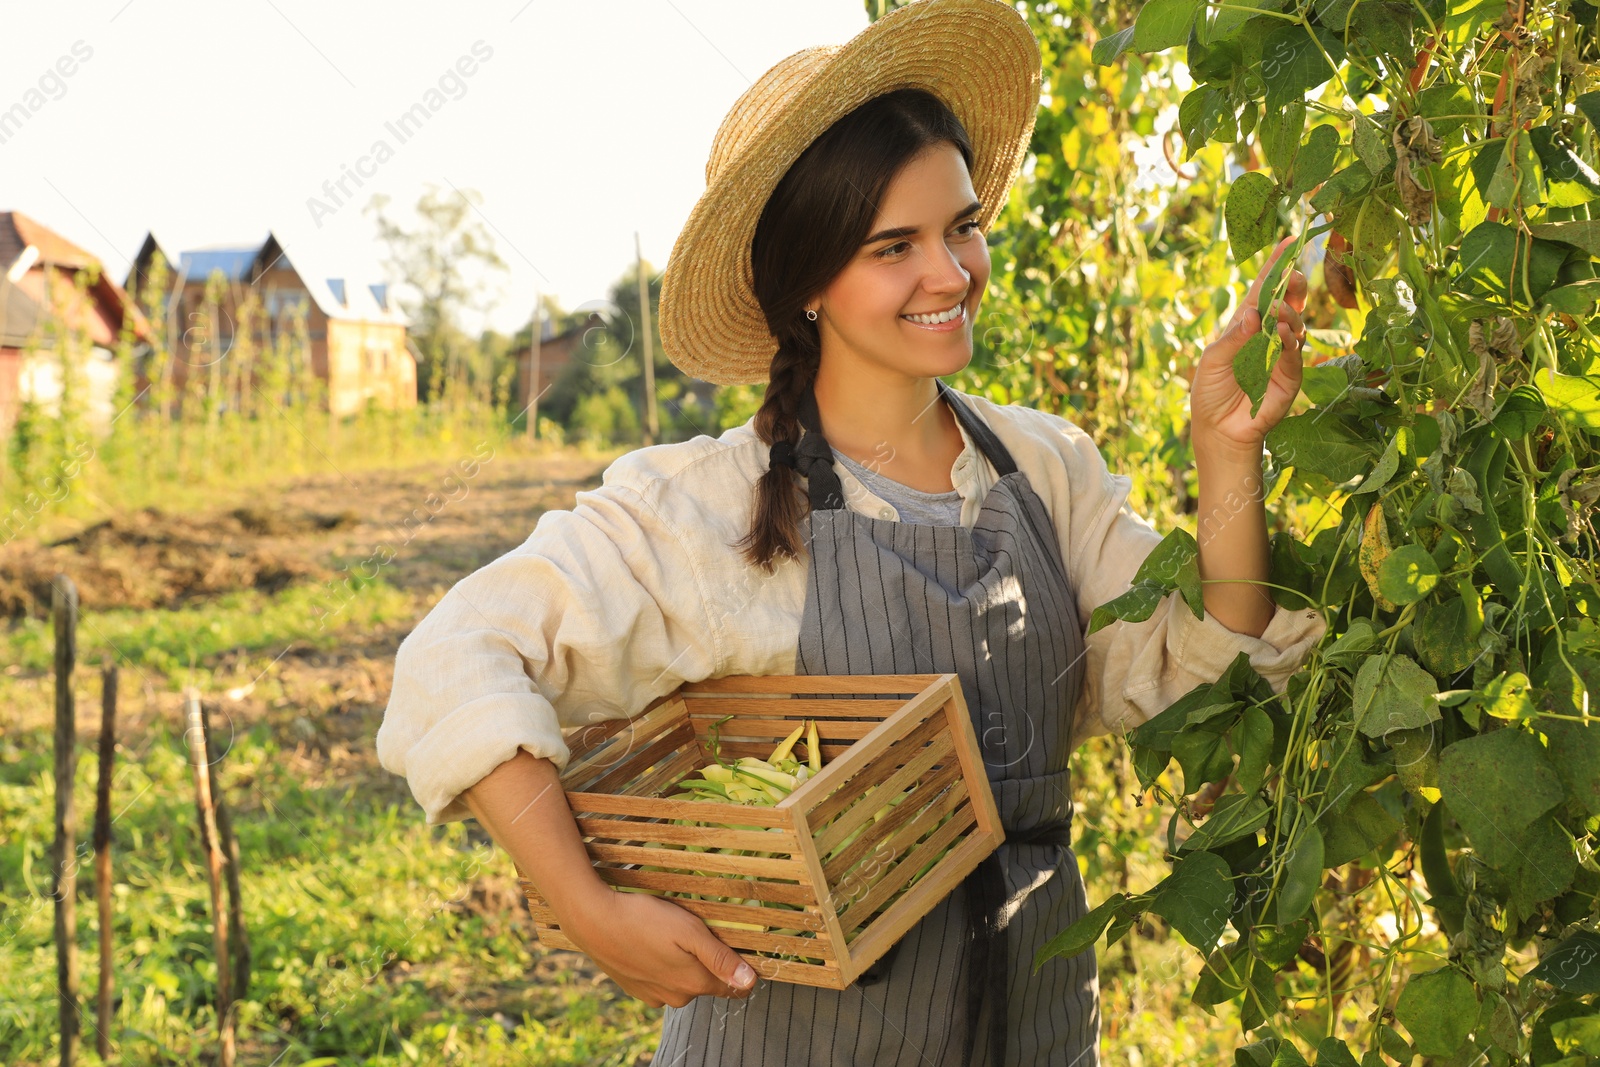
517, 673, 1005, 989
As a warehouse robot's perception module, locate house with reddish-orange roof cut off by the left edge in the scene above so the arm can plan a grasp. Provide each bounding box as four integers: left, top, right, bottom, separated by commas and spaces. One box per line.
0, 211, 149, 434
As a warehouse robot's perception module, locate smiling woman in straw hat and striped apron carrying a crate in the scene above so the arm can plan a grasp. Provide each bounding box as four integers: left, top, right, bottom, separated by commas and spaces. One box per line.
378, 0, 1323, 1065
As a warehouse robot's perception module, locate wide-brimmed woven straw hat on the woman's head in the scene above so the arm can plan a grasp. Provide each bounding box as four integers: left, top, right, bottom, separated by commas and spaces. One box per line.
661, 0, 1040, 386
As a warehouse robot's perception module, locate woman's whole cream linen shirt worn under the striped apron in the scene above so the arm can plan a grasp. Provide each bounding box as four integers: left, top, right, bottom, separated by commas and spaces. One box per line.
378, 394, 1326, 824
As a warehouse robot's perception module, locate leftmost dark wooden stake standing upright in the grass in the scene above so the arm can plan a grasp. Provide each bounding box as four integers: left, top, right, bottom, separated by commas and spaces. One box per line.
50, 574, 78, 1067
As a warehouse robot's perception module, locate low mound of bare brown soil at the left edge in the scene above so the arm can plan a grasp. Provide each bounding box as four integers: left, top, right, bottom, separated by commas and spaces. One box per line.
0, 507, 357, 619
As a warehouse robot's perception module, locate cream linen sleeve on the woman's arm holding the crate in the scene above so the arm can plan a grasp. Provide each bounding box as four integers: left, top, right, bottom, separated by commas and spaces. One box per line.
378, 466, 715, 824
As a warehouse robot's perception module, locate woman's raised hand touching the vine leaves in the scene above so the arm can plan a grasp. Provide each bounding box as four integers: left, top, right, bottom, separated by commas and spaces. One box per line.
1189, 237, 1306, 458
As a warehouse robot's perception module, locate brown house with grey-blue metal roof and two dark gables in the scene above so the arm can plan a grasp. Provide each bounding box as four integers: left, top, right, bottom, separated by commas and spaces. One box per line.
130, 234, 416, 414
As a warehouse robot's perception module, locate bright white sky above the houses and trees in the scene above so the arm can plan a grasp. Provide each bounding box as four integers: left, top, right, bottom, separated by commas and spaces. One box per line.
0, 0, 867, 331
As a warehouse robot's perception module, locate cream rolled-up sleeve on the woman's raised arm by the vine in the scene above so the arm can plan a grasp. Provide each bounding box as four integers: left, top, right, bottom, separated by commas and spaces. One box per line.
1042, 404, 1326, 742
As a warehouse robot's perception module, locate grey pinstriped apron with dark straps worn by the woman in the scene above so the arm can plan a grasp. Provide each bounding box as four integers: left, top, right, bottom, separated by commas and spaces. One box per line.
653, 381, 1099, 1067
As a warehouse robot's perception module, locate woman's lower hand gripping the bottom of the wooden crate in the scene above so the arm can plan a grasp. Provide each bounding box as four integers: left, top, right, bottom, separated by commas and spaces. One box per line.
562, 891, 755, 1008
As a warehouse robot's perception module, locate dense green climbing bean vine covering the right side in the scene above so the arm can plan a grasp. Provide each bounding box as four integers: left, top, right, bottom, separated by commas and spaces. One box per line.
1040, 0, 1600, 1067
